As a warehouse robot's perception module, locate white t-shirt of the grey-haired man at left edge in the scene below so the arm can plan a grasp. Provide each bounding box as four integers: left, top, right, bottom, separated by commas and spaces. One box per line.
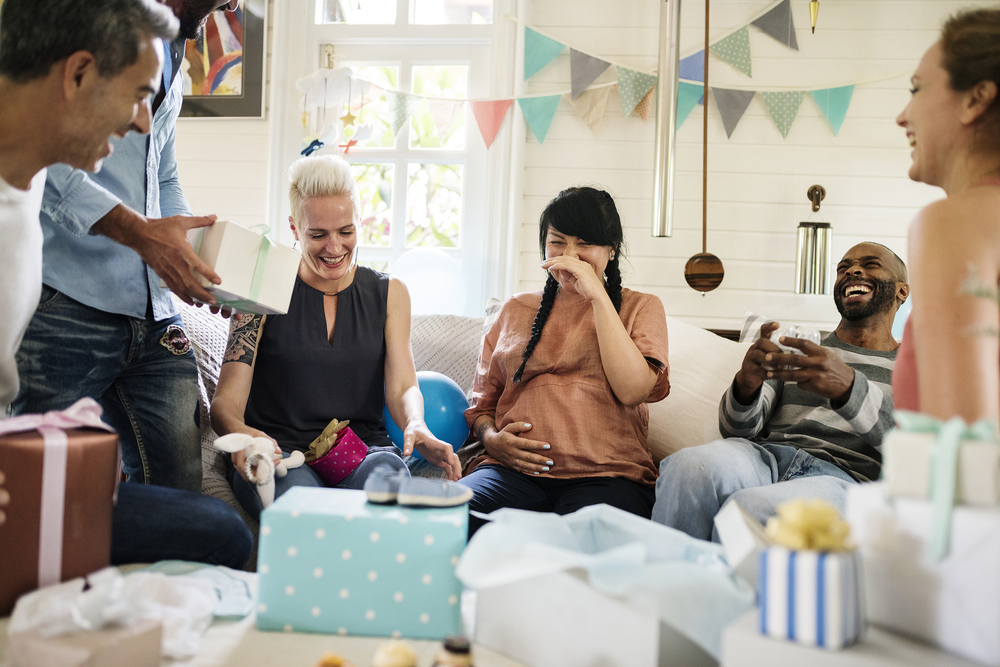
0, 169, 45, 418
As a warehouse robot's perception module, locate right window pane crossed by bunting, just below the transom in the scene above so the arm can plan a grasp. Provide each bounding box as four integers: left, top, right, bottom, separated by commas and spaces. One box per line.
410, 65, 469, 150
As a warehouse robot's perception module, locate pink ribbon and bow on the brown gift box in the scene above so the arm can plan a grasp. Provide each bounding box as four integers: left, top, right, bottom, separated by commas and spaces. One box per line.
0, 398, 114, 588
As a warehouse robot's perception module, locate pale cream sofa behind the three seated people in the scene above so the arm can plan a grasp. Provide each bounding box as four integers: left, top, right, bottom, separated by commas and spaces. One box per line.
181, 299, 750, 569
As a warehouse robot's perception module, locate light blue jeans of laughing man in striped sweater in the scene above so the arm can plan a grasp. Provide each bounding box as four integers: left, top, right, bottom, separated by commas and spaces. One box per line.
653, 438, 856, 542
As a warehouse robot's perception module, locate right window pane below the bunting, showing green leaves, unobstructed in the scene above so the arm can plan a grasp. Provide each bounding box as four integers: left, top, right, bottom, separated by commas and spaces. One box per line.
406, 164, 464, 248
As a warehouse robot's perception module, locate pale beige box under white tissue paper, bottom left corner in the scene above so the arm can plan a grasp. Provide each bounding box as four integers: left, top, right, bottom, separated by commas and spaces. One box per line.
7, 621, 163, 667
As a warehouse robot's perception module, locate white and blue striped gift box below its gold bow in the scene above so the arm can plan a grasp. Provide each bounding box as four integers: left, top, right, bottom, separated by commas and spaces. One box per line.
757, 547, 865, 649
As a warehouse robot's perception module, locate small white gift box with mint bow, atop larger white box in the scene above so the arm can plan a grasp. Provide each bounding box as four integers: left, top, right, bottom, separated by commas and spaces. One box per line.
882, 429, 1000, 507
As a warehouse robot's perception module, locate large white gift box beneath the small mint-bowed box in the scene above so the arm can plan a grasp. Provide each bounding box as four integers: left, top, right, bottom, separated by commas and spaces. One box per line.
847, 483, 1000, 665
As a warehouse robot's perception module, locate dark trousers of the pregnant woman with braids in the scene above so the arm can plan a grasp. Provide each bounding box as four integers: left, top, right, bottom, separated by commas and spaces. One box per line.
461, 464, 653, 538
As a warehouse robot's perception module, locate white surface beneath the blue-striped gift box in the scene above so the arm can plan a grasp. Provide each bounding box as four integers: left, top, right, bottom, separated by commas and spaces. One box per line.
721, 610, 981, 667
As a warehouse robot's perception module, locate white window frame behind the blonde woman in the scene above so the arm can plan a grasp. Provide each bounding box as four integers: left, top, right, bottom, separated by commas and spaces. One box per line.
269, 0, 524, 315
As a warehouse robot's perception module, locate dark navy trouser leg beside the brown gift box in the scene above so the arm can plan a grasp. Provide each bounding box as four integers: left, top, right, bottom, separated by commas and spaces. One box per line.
111, 482, 253, 569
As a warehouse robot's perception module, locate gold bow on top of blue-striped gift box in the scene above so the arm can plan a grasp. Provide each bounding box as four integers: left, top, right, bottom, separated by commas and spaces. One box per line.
766, 498, 854, 551
